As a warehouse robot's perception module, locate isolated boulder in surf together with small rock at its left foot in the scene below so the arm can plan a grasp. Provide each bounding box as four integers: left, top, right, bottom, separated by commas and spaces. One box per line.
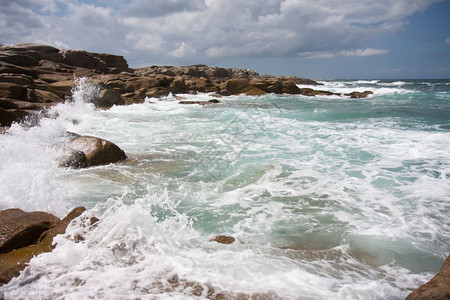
60, 136, 127, 168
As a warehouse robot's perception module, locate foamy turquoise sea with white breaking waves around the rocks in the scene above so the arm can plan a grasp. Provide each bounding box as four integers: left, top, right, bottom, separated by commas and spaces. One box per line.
0, 80, 450, 299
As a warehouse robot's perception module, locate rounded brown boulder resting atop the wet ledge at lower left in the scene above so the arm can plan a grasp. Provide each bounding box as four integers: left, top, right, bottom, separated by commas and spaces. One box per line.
0, 208, 59, 253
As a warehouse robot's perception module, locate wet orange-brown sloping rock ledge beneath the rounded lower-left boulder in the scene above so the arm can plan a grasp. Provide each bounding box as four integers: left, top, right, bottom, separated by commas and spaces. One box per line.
0, 207, 85, 285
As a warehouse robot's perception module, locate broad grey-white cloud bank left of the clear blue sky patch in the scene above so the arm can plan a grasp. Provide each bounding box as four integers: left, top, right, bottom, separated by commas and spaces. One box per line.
0, 0, 447, 63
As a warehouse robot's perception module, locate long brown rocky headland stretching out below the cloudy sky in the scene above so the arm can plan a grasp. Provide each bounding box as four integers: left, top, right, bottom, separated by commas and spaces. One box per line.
0, 44, 371, 126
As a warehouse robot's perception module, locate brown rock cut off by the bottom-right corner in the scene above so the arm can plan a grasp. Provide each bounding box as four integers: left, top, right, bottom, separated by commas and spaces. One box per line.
406, 255, 450, 300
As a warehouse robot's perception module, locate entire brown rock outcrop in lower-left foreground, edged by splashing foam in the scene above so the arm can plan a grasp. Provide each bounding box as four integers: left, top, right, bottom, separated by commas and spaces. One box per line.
0, 207, 85, 285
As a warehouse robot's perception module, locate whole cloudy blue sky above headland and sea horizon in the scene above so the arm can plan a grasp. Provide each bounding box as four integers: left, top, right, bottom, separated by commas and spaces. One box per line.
0, 0, 450, 79
